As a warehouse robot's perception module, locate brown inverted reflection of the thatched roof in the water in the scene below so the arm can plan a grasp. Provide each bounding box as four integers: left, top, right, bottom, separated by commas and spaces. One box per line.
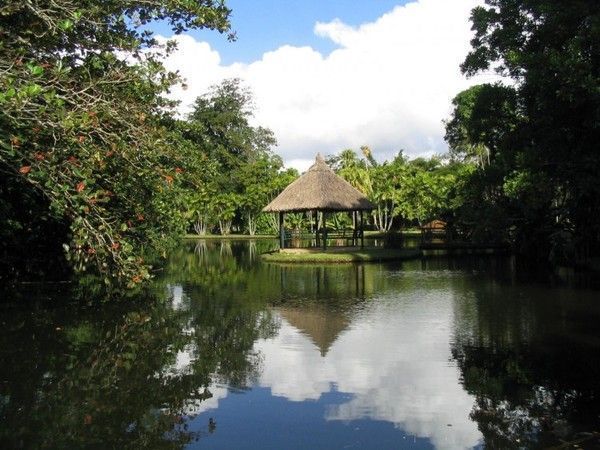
279, 306, 350, 356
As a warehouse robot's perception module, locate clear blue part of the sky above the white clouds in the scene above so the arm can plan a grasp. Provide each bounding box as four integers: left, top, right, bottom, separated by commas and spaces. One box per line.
156, 0, 408, 64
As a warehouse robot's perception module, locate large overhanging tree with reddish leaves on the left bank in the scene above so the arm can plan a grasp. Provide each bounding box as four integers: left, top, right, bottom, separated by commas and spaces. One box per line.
0, 0, 230, 284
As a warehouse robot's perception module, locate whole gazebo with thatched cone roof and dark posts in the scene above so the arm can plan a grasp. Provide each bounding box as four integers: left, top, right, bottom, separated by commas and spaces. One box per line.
263, 154, 374, 248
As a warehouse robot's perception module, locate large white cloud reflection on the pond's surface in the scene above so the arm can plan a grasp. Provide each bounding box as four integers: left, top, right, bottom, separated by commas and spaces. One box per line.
255, 290, 481, 448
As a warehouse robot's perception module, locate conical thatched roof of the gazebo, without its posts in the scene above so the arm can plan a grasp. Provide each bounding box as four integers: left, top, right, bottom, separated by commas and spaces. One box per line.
263, 154, 374, 212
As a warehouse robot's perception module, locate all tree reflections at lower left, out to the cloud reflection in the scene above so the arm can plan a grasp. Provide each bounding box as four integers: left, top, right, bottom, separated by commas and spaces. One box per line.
0, 280, 275, 448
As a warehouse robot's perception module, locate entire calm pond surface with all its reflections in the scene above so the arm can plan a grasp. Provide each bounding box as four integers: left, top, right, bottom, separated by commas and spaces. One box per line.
0, 241, 600, 449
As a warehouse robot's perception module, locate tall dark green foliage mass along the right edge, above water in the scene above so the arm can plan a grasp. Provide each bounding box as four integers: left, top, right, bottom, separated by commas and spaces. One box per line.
446, 0, 600, 263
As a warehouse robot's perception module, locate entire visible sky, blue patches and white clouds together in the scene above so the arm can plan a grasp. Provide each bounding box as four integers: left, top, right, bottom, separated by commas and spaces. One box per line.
154, 0, 495, 171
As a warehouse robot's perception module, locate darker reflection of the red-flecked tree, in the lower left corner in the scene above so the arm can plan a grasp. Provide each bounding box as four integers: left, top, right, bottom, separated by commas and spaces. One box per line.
0, 299, 197, 448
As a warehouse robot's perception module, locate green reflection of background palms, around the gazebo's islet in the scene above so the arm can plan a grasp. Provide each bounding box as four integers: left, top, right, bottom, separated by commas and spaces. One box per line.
161, 241, 391, 306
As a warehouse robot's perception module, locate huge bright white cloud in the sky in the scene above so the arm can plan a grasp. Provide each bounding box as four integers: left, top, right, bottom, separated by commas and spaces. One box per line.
157, 0, 491, 169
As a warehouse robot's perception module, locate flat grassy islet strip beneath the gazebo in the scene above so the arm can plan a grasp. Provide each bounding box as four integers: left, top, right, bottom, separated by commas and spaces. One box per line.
261, 247, 421, 263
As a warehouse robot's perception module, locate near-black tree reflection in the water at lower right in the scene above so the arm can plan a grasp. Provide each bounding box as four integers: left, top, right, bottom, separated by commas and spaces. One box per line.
452, 283, 600, 448
